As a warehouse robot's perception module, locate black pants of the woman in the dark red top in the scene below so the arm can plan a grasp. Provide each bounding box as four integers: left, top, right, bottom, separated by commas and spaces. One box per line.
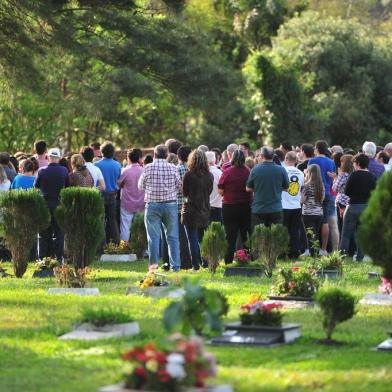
222, 204, 250, 264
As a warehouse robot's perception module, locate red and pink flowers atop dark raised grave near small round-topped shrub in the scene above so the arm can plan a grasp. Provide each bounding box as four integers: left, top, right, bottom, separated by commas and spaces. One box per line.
240, 297, 283, 327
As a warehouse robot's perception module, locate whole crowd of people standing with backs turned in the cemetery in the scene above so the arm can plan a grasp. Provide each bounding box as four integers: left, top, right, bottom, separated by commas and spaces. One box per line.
0, 139, 392, 271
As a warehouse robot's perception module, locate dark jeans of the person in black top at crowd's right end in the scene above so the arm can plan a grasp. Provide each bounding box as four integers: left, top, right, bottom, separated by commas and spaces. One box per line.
339, 204, 367, 261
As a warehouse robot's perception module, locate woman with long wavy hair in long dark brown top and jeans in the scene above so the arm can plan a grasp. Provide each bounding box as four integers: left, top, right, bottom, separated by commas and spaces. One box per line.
181, 150, 214, 271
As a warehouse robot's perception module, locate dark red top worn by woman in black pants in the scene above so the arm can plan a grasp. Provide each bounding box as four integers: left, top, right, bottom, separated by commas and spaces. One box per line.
218, 166, 252, 204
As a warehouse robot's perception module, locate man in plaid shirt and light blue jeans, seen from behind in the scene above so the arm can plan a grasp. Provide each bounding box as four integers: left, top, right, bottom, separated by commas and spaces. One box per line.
138, 144, 181, 271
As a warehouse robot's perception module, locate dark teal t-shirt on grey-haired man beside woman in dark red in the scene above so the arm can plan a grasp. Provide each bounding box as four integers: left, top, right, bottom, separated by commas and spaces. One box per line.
246, 162, 289, 214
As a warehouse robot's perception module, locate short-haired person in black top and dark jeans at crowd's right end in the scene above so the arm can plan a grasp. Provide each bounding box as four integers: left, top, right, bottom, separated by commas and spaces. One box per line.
340, 154, 377, 261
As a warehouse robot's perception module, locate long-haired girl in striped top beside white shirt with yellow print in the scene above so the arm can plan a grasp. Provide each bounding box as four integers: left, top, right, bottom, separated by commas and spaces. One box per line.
301, 165, 325, 256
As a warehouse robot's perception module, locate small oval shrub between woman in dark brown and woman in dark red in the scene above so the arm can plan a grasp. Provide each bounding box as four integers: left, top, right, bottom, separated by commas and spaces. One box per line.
200, 222, 227, 274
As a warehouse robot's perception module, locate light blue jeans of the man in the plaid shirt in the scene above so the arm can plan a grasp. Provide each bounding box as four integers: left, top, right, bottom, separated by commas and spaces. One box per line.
144, 201, 180, 271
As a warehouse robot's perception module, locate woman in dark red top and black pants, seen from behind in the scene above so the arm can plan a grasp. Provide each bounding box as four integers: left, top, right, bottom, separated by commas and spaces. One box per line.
218, 150, 252, 264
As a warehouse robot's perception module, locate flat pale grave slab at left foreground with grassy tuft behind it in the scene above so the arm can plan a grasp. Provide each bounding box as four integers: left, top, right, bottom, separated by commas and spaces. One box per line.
59, 322, 140, 340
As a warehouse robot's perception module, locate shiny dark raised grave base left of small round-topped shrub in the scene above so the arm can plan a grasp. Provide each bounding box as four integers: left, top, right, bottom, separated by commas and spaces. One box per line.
210, 323, 301, 347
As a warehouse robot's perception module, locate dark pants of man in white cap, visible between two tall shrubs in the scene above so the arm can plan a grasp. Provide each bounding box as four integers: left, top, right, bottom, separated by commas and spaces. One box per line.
39, 201, 64, 260
